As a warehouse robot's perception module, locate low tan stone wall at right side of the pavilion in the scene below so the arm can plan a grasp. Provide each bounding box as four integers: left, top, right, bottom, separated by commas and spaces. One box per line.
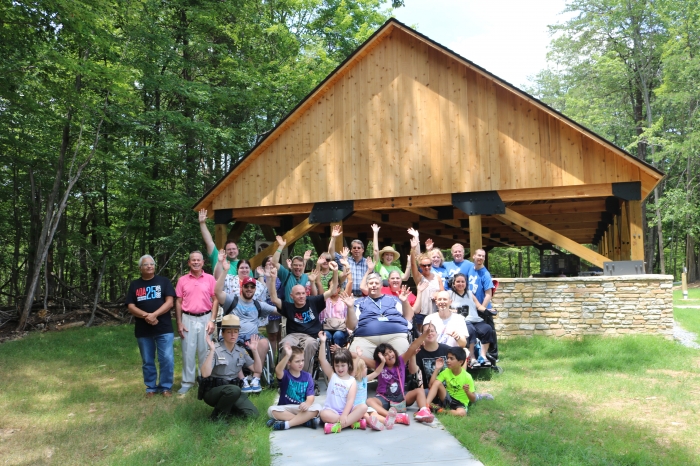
493, 275, 673, 339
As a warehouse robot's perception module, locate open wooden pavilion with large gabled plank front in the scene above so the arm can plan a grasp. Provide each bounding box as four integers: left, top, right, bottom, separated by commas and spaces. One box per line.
194, 19, 664, 267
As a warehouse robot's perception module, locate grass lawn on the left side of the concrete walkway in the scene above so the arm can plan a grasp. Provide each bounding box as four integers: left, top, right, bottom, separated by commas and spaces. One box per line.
0, 326, 275, 465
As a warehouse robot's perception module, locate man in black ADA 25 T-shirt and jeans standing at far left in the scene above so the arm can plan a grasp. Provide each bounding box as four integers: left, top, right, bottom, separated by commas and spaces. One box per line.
126, 255, 175, 397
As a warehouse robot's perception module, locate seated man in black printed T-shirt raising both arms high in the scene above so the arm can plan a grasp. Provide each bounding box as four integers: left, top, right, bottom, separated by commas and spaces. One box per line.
267, 261, 338, 374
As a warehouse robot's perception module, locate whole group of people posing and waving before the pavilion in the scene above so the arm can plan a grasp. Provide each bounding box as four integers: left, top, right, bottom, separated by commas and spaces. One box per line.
126, 210, 496, 424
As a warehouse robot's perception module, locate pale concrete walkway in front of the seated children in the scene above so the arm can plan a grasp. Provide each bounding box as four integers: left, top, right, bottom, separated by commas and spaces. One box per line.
270, 382, 483, 466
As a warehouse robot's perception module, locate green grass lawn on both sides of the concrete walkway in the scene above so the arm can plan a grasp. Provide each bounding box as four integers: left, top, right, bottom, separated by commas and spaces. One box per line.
0, 326, 700, 466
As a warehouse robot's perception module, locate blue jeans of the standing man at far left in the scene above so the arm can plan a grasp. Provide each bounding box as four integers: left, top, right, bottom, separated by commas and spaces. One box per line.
136, 333, 175, 393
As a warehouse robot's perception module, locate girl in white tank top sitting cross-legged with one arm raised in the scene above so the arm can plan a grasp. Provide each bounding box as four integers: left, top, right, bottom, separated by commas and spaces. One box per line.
318, 330, 367, 434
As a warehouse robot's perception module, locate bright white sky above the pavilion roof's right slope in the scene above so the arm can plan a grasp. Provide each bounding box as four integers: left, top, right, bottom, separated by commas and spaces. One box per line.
394, 0, 571, 87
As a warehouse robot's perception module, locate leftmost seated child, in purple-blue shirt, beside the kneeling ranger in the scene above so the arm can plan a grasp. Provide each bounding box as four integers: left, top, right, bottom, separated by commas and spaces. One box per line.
267, 344, 321, 430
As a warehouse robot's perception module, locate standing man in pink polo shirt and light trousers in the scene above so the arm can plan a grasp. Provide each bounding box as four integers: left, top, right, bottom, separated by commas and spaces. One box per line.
175, 251, 219, 395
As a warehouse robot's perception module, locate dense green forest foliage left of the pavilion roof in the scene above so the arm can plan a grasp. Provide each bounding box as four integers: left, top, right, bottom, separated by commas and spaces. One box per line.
0, 0, 394, 305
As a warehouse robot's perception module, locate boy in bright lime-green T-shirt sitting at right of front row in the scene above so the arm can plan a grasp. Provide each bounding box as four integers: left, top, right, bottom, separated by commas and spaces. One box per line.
427, 347, 493, 416
